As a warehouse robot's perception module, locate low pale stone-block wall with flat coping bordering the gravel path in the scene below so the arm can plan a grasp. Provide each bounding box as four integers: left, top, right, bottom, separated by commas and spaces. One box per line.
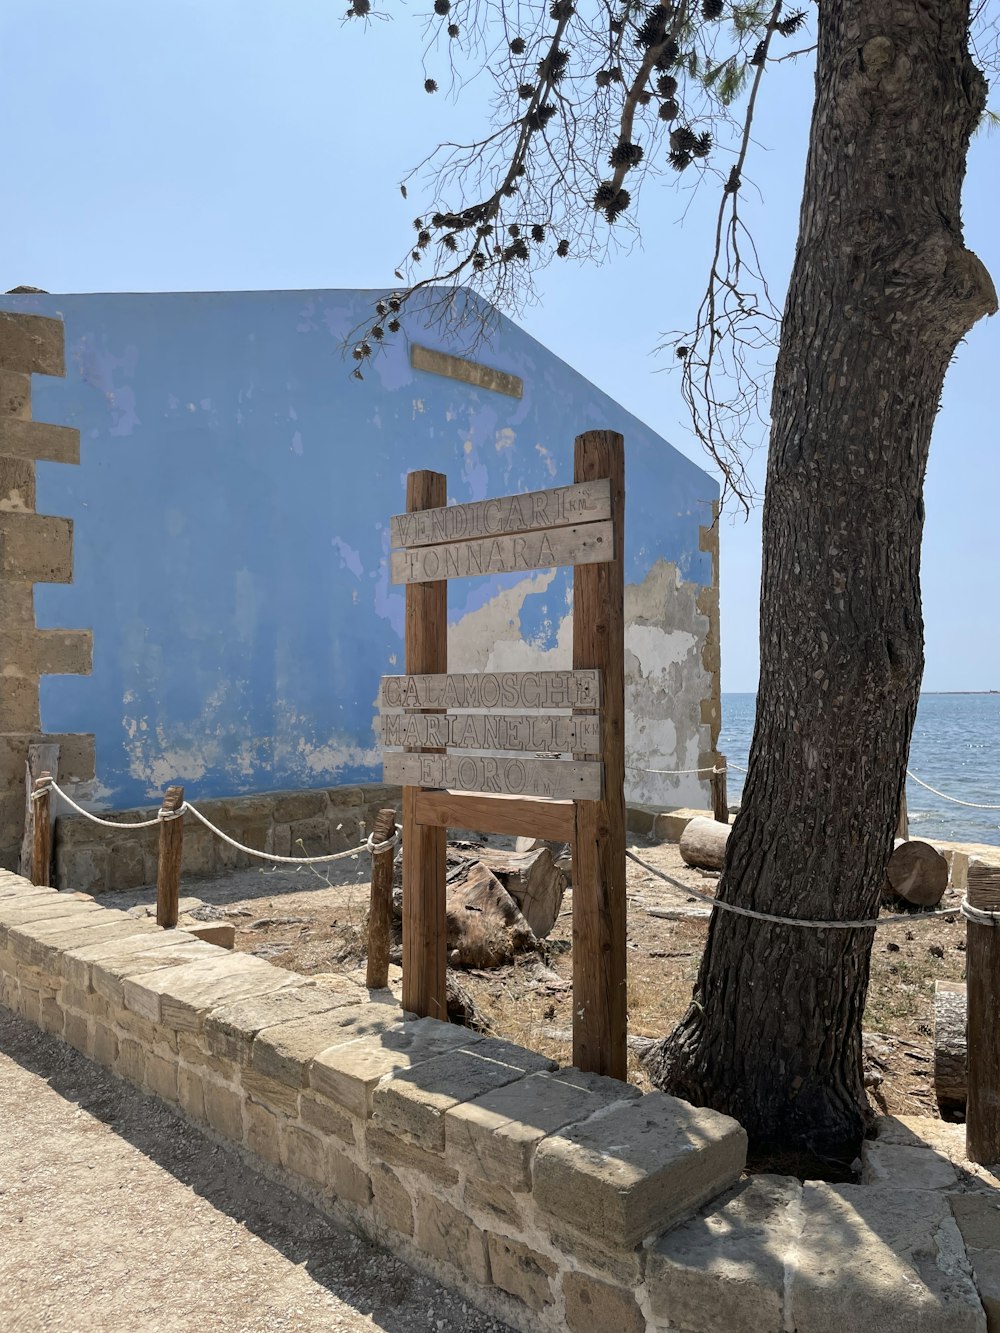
0, 873, 1000, 1333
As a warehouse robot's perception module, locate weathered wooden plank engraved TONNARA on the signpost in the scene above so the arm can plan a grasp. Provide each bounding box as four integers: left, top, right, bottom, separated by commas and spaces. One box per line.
389, 521, 613, 584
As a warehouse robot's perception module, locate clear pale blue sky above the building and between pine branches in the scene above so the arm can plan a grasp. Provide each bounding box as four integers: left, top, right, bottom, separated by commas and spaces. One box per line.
0, 0, 1000, 690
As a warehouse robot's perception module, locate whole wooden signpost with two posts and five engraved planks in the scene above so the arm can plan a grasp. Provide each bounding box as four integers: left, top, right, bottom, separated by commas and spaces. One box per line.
380, 431, 627, 1078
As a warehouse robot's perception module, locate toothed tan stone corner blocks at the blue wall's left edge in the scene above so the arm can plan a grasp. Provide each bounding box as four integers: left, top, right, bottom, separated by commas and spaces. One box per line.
0, 311, 95, 869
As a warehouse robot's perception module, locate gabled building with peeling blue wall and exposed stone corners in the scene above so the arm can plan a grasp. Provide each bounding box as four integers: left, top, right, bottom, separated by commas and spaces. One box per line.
0, 291, 720, 866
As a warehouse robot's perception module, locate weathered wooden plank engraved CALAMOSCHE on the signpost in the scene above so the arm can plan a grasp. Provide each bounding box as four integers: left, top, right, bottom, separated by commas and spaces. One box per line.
379, 670, 601, 712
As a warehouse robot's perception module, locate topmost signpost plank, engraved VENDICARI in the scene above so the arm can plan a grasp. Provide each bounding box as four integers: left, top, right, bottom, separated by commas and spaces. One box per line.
389, 477, 611, 548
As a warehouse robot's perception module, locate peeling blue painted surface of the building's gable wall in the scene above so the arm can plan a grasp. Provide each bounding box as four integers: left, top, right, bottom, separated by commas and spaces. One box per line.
1, 291, 717, 806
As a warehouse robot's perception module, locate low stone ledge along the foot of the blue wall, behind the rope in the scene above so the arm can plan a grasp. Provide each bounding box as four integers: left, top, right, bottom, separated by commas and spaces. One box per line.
55, 782, 401, 893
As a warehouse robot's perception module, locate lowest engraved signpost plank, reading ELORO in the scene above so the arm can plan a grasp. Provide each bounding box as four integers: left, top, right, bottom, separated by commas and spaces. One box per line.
383, 753, 601, 801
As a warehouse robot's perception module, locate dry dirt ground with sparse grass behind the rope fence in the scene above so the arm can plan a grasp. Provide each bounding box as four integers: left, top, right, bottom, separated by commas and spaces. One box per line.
105, 838, 965, 1116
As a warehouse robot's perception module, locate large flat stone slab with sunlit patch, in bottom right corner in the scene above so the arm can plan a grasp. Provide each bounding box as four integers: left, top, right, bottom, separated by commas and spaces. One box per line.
785, 1182, 987, 1333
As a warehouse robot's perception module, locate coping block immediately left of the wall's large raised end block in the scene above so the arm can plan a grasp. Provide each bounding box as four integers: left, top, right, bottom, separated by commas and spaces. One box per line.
444, 1069, 639, 1190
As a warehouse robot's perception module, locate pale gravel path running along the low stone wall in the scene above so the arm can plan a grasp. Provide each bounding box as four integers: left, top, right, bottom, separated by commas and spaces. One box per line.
0, 1006, 507, 1333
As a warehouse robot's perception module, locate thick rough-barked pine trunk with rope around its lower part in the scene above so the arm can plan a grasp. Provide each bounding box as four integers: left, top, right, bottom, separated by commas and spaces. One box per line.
647, 0, 996, 1161
